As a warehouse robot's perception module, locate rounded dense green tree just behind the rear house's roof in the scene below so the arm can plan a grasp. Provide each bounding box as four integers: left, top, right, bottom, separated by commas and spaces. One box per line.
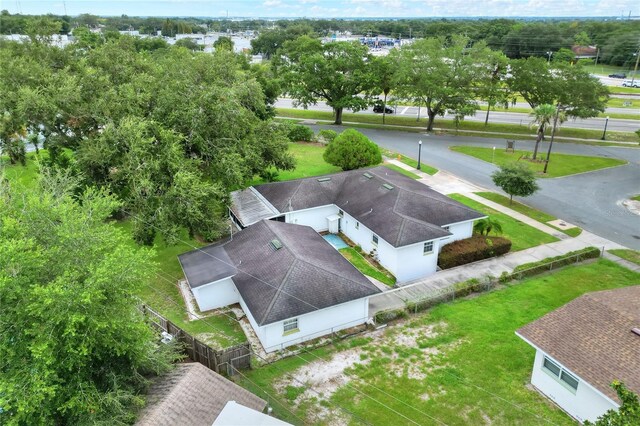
322, 129, 382, 170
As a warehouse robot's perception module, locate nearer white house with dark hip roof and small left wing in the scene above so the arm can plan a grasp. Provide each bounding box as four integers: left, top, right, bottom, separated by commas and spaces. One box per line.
178, 220, 380, 352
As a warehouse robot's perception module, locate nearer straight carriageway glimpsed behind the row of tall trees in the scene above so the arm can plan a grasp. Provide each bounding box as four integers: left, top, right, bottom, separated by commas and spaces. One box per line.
275, 98, 640, 132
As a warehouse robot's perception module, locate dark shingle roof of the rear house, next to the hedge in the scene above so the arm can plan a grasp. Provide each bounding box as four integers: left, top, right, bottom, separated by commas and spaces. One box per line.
232, 166, 484, 247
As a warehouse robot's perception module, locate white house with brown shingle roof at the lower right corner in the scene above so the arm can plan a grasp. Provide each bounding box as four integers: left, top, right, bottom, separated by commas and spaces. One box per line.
516, 286, 640, 422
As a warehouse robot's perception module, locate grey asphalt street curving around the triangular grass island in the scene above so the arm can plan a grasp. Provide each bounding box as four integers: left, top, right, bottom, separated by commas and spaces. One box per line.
313, 126, 640, 250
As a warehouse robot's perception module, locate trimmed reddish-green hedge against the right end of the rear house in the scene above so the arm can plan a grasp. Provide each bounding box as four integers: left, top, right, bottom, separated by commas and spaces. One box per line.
438, 234, 511, 269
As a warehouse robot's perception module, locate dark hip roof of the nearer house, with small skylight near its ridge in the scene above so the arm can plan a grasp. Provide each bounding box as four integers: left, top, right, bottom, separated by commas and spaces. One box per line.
181, 220, 380, 325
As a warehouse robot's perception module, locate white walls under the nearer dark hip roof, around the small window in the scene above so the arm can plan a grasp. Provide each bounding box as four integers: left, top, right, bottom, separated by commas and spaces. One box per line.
240, 298, 369, 352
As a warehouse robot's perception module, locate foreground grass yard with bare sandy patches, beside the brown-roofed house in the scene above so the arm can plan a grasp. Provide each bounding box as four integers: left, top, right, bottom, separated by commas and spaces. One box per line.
238, 259, 640, 425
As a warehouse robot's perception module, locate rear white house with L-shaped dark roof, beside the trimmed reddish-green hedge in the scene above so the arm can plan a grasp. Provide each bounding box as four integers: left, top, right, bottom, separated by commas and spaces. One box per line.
230, 166, 485, 282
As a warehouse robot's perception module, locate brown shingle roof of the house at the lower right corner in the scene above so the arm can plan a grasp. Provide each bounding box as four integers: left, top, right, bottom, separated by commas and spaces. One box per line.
517, 285, 640, 402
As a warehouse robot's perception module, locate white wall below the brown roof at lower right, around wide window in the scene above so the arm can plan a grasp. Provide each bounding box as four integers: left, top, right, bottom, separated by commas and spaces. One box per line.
531, 349, 618, 422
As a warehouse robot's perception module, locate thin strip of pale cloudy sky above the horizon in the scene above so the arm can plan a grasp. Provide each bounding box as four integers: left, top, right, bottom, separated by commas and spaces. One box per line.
0, 0, 640, 18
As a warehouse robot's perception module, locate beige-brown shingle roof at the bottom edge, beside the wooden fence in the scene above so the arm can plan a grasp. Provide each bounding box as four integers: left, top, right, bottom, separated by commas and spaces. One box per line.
136, 363, 267, 426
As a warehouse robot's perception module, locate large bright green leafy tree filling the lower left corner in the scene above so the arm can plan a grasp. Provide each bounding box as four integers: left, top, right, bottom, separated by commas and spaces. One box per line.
0, 169, 175, 425
